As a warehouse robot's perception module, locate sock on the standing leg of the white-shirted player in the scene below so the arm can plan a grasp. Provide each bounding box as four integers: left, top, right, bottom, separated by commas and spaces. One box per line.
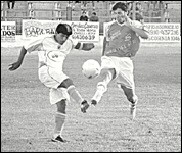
54, 112, 65, 138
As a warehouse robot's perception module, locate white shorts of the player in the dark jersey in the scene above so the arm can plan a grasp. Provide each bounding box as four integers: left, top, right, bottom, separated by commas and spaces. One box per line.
101, 56, 135, 89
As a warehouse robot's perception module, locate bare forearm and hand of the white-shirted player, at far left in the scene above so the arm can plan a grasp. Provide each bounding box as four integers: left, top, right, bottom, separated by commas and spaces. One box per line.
9, 47, 27, 71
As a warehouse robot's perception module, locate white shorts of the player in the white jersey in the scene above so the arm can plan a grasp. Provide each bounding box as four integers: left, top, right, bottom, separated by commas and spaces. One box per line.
39, 65, 70, 104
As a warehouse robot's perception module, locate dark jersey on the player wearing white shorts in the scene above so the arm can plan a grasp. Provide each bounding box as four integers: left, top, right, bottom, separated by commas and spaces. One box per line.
104, 23, 140, 57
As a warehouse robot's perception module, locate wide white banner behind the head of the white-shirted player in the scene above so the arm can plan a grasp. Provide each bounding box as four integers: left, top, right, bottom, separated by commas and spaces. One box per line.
23, 20, 99, 42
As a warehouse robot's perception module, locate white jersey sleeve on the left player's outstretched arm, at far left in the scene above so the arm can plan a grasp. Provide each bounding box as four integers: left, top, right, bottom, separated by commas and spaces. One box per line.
24, 38, 43, 53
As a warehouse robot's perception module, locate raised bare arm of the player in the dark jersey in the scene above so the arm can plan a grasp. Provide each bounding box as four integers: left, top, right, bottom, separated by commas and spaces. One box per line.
126, 16, 148, 39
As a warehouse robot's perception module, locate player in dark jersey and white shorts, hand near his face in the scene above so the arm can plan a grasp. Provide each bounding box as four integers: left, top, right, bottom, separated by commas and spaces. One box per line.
91, 2, 148, 119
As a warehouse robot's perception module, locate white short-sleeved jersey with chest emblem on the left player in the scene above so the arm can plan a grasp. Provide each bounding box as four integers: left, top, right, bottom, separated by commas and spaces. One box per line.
24, 36, 77, 71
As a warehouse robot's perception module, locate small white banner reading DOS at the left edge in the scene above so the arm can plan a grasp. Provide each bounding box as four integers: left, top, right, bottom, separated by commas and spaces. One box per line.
1, 21, 16, 42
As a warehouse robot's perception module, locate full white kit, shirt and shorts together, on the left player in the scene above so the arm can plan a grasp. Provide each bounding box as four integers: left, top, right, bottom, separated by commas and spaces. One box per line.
24, 36, 78, 104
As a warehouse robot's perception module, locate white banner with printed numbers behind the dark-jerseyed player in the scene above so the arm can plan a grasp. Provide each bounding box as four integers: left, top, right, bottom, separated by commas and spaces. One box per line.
103, 22, 181, 42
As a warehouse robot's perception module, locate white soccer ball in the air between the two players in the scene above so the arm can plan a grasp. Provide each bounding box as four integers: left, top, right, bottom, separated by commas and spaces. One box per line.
82, 59, 100, 79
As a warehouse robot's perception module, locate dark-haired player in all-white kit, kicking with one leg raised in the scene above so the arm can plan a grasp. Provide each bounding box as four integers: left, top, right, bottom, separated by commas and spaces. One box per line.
9, 24, 94, 142
